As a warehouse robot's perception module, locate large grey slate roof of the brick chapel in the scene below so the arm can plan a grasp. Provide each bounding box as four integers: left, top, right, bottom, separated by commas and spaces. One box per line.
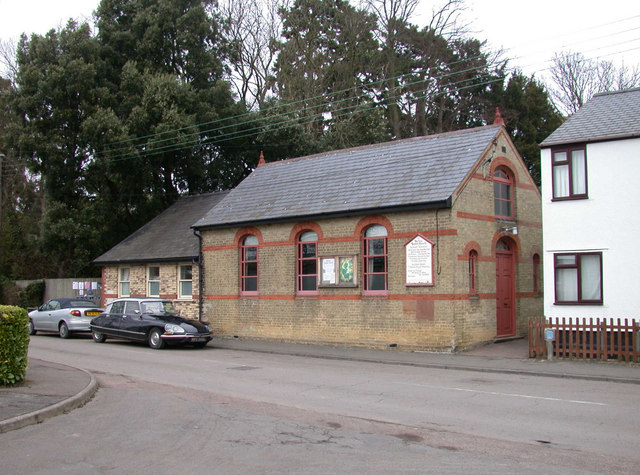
194, 125, 501, 228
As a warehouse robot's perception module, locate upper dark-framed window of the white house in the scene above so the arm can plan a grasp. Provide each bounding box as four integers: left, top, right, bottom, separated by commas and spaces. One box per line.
551, 146, 587, 200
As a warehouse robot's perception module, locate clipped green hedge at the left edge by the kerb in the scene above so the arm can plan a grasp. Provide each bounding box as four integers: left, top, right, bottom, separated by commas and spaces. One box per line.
0, 305, 29, 385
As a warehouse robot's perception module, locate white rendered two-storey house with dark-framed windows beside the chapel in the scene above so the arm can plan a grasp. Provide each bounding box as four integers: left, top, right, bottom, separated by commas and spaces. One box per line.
541, 88, 640, 318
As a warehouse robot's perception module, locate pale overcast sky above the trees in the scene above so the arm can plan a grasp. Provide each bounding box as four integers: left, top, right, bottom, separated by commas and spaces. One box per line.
0, 0, 640, 78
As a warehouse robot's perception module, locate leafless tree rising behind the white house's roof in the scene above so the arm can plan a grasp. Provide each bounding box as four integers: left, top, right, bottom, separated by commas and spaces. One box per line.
550, 52, 640, 114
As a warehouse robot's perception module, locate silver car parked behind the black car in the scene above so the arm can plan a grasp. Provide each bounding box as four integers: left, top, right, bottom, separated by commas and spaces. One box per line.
29, 298, 104, 338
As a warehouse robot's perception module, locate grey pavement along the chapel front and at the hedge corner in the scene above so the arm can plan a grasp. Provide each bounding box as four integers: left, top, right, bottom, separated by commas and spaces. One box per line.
0, 339, 640, 433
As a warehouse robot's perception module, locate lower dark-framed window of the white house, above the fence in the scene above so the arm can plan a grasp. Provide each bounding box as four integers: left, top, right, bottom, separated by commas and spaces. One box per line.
553, 252, 602, 305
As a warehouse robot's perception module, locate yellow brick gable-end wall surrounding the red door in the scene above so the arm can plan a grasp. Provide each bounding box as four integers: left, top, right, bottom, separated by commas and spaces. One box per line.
454, 132, 543, 346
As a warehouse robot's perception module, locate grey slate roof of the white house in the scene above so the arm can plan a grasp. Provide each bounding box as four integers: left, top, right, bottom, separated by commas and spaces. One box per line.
540, 88, 640, 147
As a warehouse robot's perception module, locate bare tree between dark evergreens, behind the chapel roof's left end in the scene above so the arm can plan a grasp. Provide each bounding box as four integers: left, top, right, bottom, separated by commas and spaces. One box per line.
220, 0, 290, 109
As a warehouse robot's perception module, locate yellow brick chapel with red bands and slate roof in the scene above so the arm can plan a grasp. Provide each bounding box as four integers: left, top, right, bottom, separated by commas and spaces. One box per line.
192, 124, 542, 351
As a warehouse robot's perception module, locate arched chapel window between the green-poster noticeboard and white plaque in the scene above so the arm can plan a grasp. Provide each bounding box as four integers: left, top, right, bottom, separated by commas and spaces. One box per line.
362, 224, 388, 293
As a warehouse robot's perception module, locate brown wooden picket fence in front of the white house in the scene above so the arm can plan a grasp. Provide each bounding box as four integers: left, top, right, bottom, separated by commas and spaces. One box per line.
529, 317, 640, 362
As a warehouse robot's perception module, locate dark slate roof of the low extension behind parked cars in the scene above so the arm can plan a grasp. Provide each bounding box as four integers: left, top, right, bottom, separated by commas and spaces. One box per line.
93, 191, 228, 265
